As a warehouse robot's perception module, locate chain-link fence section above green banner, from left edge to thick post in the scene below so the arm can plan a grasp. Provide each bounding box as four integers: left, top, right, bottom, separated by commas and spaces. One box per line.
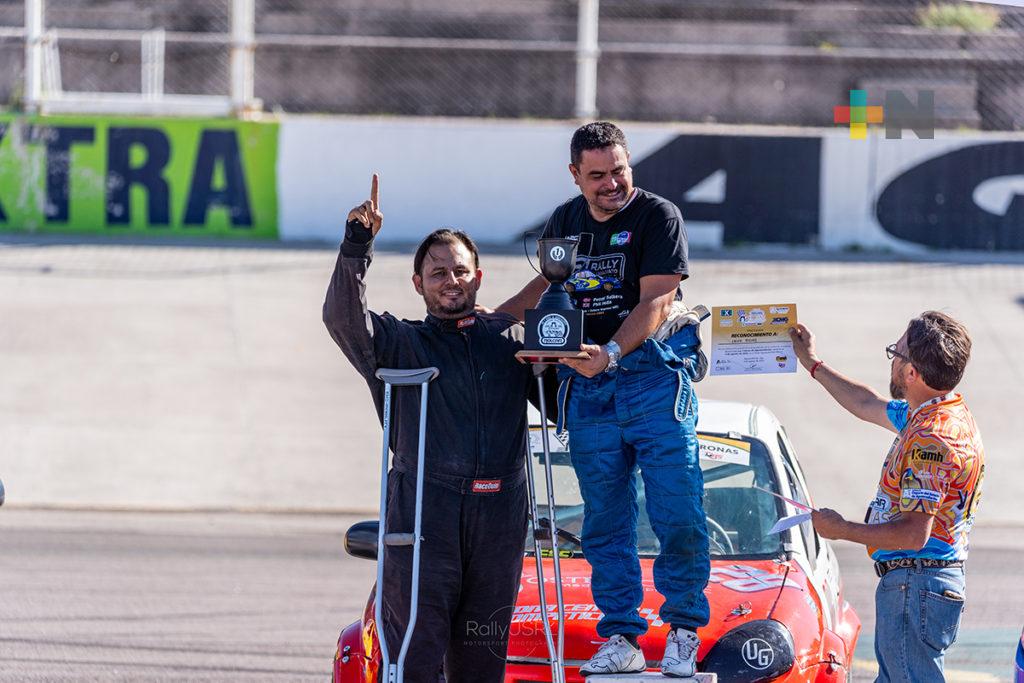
0, 0, 232, 114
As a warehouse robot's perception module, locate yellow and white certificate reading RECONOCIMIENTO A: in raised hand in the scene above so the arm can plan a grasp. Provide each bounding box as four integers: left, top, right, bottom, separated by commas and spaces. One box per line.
711, 303, 797, 375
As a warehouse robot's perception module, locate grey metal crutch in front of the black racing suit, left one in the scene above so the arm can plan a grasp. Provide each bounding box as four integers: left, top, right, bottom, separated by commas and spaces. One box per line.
374, 368, 438, 683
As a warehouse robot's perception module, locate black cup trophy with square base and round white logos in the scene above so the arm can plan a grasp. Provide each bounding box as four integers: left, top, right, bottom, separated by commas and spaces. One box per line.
516, 238, 587, 364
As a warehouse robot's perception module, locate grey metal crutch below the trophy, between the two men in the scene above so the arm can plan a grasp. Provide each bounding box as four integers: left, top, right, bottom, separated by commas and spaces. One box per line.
526, 362, 565, 683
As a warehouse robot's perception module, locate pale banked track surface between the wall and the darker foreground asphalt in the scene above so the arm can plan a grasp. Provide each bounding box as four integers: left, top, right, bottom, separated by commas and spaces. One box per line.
0, 241, 1024, 524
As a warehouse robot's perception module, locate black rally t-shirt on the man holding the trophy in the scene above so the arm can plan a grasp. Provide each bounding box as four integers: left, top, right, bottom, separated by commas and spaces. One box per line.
544, 188, 689, 344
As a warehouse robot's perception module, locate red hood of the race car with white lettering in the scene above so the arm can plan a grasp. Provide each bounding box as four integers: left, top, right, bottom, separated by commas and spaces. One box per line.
508, 557, 820, 661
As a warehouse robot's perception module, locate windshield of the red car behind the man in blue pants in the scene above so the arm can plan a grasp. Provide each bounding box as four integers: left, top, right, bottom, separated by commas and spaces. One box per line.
527, 428, 784, 558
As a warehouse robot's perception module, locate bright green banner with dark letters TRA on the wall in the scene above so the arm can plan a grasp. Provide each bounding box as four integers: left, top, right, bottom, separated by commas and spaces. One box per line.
0, 115, 278, 239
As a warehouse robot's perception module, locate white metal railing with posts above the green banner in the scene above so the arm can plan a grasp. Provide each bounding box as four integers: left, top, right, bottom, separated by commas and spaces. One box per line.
24, 0, 245, 116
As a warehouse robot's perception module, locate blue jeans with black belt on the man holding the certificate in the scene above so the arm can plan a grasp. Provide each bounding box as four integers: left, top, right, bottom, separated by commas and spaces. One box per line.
874, 567, 966, 683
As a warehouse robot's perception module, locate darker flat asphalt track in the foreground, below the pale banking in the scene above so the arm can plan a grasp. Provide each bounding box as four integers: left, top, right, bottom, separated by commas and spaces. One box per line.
0, 508, 1024, 683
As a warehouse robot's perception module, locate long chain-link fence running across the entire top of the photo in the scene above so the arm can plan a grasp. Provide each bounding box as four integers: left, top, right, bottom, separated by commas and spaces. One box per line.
0, 0, 1024, 130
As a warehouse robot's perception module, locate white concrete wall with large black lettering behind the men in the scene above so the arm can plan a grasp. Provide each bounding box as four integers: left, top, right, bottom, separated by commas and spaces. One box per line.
279, 117, 1024, 252
